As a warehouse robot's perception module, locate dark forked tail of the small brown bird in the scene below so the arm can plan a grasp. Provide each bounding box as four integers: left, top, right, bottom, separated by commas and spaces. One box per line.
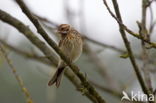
48, 67, 65, 88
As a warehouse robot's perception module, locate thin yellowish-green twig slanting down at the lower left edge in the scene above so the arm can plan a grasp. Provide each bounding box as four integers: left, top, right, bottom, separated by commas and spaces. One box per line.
0, 43, 34, 103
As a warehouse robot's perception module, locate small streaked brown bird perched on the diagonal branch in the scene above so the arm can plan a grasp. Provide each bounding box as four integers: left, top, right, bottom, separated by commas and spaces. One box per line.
48, 24, 83, 88
